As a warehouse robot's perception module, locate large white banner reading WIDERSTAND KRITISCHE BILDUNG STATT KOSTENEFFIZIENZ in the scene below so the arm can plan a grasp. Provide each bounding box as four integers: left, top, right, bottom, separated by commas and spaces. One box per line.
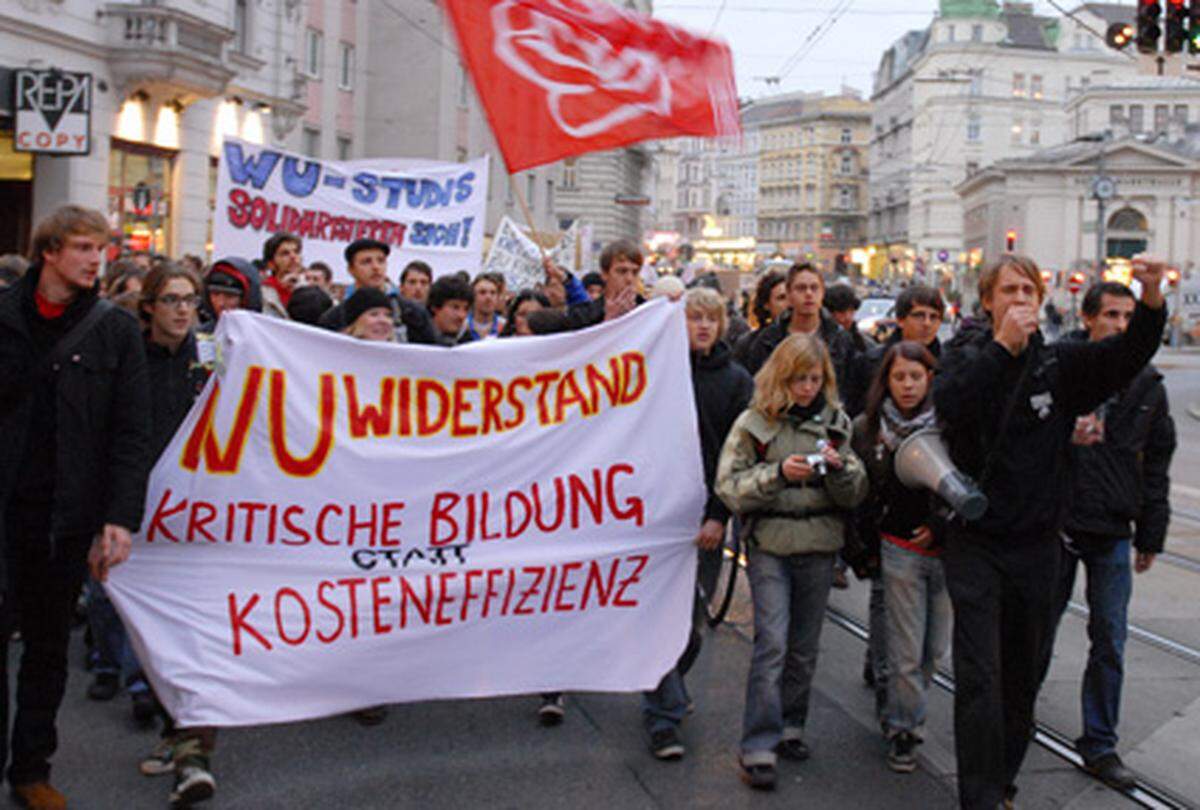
108, 301, 704, 726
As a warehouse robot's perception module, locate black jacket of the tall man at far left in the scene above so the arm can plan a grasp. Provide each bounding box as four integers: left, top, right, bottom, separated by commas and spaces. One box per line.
0, 266, 150, 554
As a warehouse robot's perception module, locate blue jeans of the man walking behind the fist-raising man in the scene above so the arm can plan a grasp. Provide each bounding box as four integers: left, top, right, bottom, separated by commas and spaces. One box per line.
1057, 540, 1133, 760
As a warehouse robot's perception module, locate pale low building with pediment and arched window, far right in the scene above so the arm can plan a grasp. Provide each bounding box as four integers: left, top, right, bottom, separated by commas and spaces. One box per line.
956, 77, 1200, 272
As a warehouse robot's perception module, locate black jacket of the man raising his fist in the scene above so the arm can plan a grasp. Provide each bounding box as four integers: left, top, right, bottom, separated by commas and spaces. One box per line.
934, 302, 1166, 544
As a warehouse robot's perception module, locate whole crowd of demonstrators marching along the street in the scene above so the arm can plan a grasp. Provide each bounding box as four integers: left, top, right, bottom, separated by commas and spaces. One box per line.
0, 206, 1175, 809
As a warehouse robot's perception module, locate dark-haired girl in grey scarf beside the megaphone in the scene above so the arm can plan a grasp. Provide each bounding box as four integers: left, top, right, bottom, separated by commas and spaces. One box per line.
852, 341, 950, 773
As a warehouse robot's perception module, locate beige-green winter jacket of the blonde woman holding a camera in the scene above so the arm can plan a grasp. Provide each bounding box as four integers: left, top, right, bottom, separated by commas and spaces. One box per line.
716, 406, 866, 557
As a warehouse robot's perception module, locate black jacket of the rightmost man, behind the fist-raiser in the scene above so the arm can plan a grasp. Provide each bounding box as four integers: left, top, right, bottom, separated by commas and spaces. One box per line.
1064, 334, 1176, 554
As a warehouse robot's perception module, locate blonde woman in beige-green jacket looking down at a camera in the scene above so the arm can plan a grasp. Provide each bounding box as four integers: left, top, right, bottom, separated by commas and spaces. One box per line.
716, 335, 866, 790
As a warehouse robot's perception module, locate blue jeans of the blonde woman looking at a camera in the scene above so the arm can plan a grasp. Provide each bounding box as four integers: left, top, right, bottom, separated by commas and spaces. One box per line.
742, 551, 833, 766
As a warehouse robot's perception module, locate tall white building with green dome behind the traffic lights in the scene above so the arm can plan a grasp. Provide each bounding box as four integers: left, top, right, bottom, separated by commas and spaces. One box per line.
870, 0, 1138, 272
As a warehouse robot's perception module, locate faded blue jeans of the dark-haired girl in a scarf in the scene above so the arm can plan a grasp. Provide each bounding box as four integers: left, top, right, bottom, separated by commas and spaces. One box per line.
881, 540, 953, 737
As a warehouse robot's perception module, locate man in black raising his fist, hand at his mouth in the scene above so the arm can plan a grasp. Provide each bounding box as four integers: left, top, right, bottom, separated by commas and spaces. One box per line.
934, 256, 1166, 810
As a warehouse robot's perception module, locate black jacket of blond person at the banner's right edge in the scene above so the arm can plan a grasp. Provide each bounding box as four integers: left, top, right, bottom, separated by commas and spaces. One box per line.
691, 342, 754, 523
